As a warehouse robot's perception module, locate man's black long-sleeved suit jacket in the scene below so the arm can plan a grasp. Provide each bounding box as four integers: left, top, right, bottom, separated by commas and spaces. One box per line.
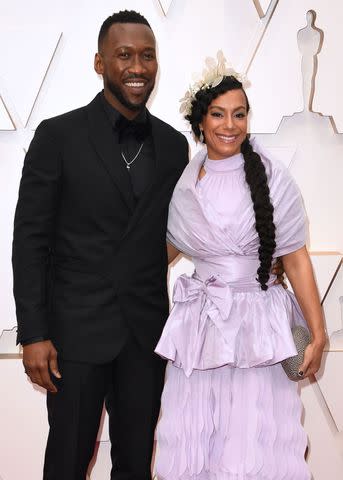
13, 94, 188, 363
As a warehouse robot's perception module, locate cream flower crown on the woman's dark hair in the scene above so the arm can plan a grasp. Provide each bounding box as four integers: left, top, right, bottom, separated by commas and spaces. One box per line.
180, 50, 249, 116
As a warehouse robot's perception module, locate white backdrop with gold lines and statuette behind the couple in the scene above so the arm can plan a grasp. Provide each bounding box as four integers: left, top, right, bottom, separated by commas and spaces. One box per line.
0, 0, 343, 480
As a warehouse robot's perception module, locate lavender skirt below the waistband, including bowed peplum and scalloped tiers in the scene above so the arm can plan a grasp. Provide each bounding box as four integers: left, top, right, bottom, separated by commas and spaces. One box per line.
155, 276, 311, 480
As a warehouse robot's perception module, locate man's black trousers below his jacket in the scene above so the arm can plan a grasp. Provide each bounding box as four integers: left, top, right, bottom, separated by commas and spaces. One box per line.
43, 336, 165, 480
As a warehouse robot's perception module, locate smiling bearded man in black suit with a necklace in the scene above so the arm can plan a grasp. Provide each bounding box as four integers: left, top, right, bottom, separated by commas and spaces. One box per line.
13, 11, 188, 480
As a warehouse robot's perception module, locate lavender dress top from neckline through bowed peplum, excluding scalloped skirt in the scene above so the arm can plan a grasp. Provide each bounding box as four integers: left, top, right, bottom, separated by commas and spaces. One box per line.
156, 144, 306, 376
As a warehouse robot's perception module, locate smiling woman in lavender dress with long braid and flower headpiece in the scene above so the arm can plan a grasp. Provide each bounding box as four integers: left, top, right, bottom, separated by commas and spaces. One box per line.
155, 53, 325, 480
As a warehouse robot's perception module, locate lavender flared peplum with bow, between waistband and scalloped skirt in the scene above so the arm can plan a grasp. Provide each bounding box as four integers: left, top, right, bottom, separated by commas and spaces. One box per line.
156, 275, 304, 376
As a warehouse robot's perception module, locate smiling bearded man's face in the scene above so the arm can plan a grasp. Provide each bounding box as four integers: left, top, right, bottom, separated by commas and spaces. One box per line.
94, 23, 158, 118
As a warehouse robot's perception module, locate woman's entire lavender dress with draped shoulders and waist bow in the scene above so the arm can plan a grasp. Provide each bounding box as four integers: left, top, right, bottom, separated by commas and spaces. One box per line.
155, 146, 310, 480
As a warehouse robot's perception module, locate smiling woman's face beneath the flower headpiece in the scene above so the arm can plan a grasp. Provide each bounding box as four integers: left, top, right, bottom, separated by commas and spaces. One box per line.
199, 89, 248, 160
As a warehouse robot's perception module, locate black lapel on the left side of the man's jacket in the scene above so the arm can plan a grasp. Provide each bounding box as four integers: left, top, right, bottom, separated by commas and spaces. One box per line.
87, 93, 135, 212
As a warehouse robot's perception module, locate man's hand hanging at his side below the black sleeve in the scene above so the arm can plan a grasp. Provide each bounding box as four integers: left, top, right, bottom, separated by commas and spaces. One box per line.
23, 340, 62, 393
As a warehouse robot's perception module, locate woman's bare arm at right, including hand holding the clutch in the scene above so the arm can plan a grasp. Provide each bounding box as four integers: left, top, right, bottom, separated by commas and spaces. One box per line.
282, 247, 326, 377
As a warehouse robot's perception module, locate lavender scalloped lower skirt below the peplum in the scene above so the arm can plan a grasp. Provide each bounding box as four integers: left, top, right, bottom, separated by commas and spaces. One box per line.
155, 362, 311, 480
